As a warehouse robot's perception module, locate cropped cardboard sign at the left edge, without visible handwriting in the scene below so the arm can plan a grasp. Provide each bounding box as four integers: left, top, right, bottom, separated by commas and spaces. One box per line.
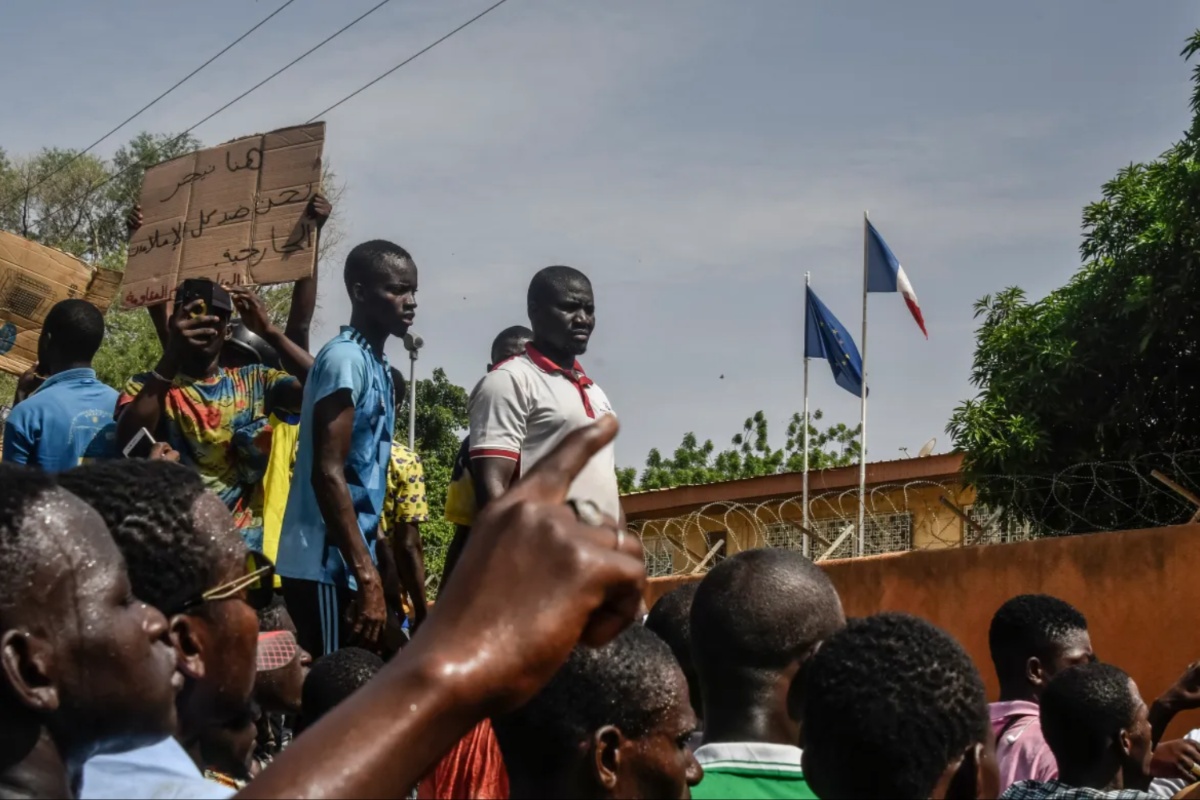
0, 230, 121, 375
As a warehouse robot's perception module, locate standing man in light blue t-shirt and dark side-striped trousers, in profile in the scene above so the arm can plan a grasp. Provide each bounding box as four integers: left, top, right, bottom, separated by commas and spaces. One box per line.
277, 240, 416, 655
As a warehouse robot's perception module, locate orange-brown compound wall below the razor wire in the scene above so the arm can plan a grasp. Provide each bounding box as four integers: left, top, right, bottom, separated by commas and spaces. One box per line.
647, 525, 1200, 735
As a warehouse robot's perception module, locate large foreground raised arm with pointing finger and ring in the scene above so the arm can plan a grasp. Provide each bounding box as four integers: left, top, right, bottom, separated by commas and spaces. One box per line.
238, 419, 646, 798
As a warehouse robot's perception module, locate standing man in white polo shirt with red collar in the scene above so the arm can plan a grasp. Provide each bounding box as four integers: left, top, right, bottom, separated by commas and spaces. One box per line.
470, 266, 624, 524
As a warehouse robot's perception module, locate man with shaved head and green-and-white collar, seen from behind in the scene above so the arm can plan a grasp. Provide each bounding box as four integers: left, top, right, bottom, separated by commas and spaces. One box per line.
691, 548, 846, 800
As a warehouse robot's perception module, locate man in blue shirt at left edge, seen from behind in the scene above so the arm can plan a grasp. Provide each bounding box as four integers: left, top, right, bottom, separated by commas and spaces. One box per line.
4, 299, 116, 473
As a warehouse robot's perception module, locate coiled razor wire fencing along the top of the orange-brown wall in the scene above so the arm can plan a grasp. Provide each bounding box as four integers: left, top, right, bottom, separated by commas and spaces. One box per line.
630, 451, 1200, 577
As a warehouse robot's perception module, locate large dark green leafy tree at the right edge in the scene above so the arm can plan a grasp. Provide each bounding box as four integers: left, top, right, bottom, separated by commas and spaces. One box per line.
947, 31, 1200, 533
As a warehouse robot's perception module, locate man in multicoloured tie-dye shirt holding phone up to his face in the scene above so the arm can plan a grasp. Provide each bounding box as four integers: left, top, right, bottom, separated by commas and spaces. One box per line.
116, 284, 312, 549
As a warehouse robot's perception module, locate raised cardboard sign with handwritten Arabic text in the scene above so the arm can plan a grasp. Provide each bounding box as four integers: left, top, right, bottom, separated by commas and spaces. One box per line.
121, 122, 325, 308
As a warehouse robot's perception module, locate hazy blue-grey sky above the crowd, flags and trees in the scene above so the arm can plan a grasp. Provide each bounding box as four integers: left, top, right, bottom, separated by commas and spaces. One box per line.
0, 0, 1200, 467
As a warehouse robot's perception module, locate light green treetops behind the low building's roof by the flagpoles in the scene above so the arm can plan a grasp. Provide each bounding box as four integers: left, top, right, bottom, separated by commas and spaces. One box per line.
617, 409, 859, 494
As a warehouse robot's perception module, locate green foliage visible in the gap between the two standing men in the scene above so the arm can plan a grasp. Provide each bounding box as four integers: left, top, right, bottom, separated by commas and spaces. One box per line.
395, 367, 469, 587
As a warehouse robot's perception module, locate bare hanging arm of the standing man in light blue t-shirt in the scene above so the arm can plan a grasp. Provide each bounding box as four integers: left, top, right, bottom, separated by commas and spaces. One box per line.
310, 389, 388, 649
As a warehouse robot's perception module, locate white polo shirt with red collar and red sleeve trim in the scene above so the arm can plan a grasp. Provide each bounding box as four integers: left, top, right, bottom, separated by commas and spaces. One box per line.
469, 344, 620, 519
